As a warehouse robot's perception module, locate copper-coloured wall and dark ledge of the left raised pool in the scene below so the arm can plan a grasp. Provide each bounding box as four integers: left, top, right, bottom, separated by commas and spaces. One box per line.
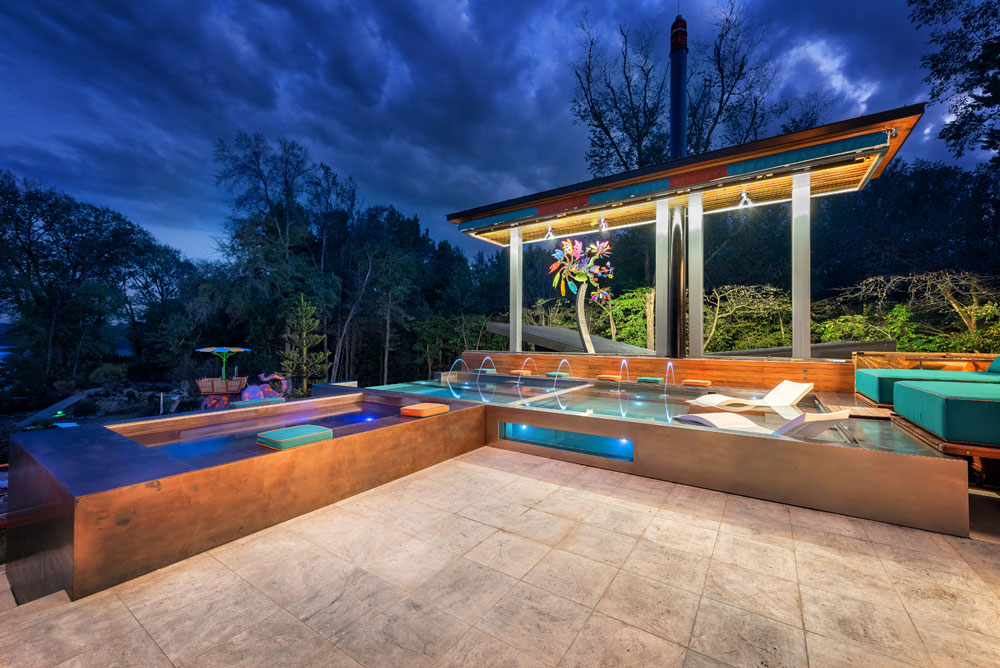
7, 389, 486, 603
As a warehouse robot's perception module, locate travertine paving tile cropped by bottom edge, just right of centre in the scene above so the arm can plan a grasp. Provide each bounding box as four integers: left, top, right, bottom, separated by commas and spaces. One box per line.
559, 613, 684, 668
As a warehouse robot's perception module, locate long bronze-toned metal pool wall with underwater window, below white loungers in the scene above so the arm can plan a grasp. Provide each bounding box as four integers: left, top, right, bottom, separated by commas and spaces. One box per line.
486, 406, 969, 537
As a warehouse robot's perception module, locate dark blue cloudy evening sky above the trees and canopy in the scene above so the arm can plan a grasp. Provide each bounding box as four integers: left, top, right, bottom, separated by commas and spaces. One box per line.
0, 0, 975, 257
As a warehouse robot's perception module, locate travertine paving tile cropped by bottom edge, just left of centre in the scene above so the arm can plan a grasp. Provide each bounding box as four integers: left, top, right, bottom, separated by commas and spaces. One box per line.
337, 597, 469, 668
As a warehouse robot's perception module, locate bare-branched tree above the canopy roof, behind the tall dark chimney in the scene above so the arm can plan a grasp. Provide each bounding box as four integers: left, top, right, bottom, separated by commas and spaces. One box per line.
571, 0, 792, 176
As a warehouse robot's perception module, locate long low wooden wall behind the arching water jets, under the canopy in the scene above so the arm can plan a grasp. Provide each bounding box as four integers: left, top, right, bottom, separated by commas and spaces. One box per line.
462, 350, 854, 392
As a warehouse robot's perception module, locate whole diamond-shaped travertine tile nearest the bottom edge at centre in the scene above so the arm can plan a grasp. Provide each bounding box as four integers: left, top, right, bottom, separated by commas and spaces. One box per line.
476, 582, 590, 666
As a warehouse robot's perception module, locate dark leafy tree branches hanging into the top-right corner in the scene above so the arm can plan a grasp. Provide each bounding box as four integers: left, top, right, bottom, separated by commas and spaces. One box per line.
907, 0, 1000, 168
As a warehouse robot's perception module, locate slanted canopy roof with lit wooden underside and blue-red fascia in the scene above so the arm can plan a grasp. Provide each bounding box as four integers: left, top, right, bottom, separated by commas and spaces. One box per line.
448, 103, 925, 246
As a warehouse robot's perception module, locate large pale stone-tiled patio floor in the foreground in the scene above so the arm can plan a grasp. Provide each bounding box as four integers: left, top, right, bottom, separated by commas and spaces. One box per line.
0, 448, 1000, 668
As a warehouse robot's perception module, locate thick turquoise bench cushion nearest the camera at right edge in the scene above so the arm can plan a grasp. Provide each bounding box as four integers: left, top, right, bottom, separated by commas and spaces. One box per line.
893, 381, 1000, 446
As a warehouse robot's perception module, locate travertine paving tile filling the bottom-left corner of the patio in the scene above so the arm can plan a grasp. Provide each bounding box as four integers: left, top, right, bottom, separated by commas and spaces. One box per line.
0, 592, 139, 666
